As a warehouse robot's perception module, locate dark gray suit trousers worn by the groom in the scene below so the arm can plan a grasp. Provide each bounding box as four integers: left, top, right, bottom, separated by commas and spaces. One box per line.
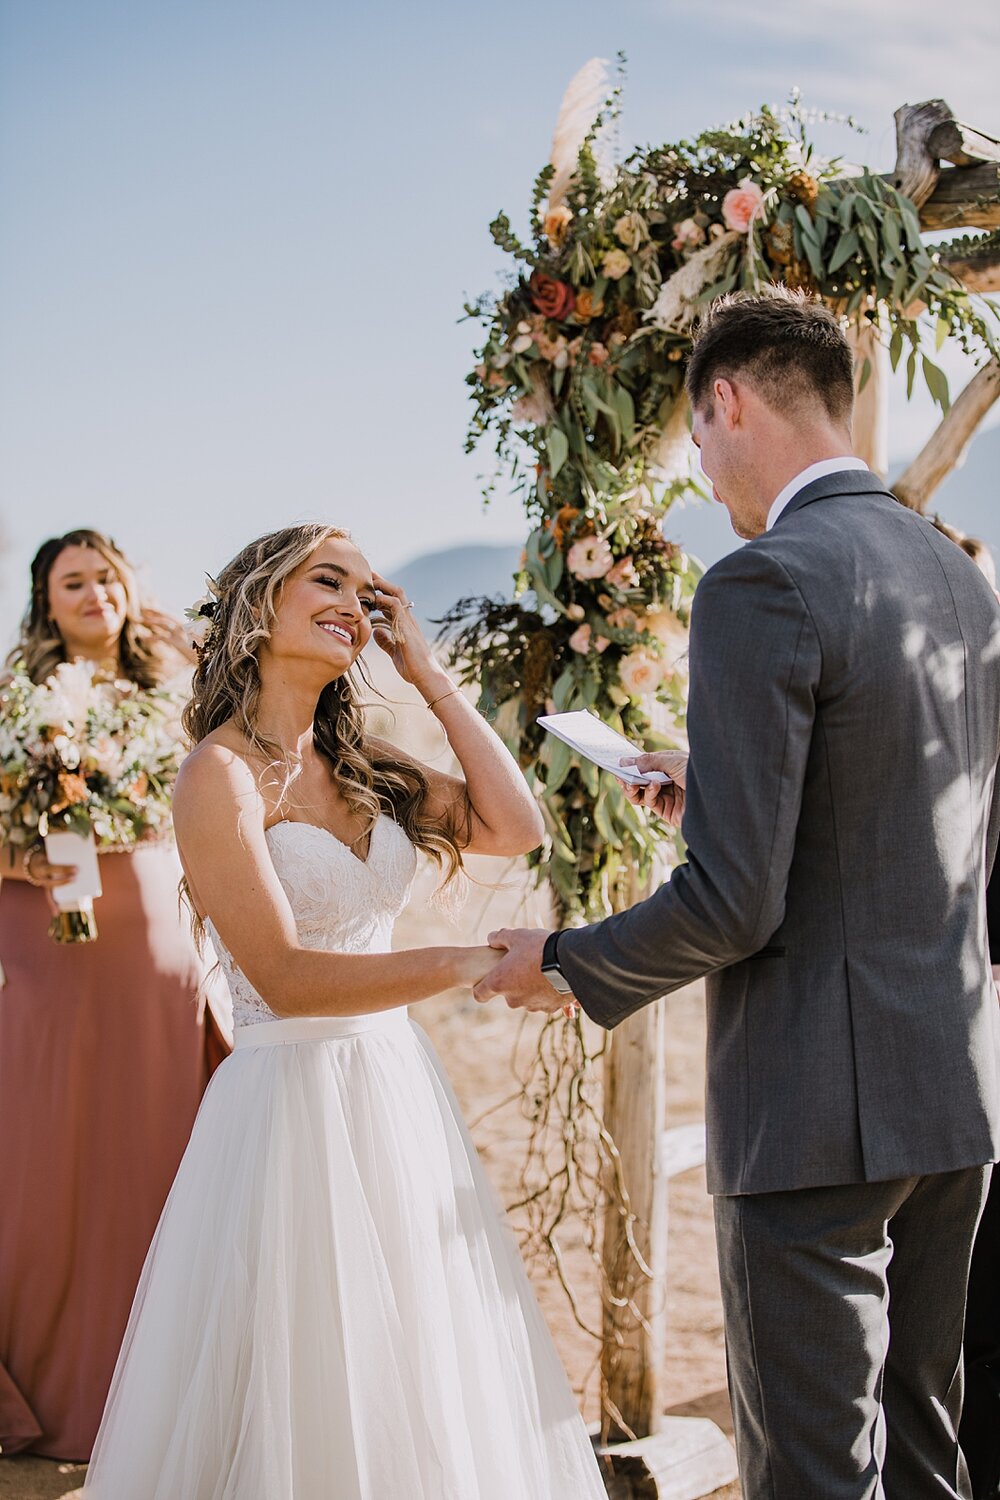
715, 1167, 988, 1500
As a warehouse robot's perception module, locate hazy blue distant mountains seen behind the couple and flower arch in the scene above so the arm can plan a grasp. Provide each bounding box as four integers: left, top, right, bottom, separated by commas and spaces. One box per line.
396, 428, 1000, 630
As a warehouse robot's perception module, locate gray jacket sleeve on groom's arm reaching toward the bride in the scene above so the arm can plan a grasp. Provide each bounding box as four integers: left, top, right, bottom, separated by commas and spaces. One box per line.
559, 545, 822, 1028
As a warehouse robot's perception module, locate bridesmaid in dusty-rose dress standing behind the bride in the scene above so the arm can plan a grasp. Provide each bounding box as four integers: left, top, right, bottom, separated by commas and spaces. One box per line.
0, 530, 228, 1460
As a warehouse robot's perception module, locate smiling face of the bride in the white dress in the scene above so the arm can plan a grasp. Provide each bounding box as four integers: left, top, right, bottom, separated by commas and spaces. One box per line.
264, 539, 378, 680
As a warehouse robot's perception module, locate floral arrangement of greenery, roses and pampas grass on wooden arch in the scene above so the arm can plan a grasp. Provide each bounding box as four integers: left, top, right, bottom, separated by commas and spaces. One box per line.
445, 60, 997, 920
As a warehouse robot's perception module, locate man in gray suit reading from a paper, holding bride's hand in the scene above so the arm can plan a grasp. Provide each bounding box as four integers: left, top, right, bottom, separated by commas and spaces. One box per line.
477, 293, 1000, 1500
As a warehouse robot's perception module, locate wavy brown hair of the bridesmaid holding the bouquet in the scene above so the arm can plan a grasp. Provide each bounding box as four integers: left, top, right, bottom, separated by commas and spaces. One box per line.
7, 527, 189, 689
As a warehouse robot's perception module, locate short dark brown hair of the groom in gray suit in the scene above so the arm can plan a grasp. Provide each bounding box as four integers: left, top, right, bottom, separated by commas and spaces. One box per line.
687, 287, 855, 425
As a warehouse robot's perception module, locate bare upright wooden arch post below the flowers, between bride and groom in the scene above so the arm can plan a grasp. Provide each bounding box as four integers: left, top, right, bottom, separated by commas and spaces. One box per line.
601, 1001, 667, 1440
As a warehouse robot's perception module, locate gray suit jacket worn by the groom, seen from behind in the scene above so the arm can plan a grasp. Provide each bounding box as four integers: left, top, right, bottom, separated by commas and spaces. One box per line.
559, 471, 1000, 1194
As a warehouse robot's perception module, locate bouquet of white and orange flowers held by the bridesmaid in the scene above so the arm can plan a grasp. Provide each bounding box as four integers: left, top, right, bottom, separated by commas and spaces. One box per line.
0, 660, 183, 942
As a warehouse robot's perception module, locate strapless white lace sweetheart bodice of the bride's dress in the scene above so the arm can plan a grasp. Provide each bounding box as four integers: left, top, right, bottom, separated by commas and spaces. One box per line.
205, 815, 417, 1026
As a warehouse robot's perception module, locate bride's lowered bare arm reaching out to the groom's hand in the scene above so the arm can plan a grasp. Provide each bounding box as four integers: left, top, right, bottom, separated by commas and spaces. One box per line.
174, 743, 496, 1017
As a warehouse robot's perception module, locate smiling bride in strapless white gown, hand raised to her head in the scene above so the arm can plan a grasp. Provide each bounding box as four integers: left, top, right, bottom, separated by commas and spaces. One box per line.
82, 525, 604, 1500
